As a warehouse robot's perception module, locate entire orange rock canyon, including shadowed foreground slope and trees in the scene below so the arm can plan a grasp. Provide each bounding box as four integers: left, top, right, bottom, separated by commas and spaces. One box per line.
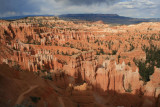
0, 16, 160, 107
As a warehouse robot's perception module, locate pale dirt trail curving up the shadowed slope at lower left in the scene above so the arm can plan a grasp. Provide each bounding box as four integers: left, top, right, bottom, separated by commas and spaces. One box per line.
16, 85, 38, 105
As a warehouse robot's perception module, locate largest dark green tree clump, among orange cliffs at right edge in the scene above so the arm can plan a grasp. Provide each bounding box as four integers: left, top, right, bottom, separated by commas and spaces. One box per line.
134, 44, 160, 82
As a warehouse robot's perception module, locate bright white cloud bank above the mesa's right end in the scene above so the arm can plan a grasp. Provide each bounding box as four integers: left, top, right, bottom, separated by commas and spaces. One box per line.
112, 0, 160, 18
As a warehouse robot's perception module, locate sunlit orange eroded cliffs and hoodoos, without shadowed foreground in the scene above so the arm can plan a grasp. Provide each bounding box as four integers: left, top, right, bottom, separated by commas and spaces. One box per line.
0, 17, 160, 106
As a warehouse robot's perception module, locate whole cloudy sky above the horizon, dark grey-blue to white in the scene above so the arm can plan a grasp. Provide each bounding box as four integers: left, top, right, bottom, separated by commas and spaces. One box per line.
0, 0, 160, 18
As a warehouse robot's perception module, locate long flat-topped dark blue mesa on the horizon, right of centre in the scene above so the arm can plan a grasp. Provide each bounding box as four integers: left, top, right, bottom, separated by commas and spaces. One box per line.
59, 14, 160, 25
